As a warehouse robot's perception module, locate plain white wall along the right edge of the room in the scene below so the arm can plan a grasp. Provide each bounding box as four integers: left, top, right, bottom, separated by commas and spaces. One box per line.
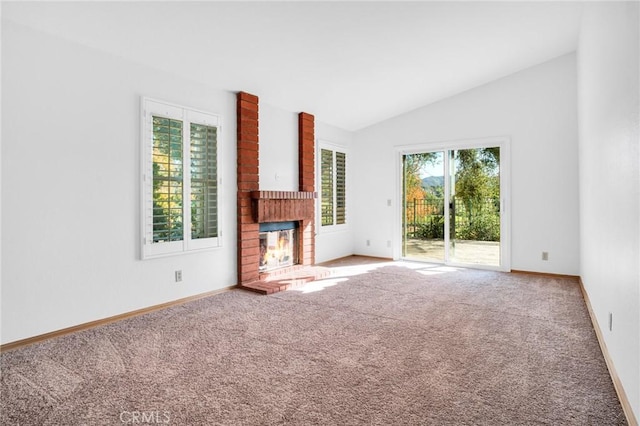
578, 2, 640, 419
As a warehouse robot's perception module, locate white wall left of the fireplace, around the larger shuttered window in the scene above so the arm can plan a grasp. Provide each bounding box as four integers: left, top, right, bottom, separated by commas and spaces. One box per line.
2, 21, 237, 343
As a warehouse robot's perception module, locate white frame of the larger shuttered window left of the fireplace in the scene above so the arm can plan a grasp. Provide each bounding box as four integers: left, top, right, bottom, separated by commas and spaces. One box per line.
140, 96, 222, 259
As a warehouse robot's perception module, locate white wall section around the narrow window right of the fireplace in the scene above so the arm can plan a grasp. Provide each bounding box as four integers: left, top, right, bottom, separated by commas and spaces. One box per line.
316, 121, 359, 263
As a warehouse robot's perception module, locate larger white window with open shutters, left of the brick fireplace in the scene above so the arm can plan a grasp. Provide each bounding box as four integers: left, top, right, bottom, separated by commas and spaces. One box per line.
142, 98, 220, 258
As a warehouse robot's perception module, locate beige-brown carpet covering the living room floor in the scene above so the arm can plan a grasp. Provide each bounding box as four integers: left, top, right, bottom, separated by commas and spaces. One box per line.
0, 263, 626, 426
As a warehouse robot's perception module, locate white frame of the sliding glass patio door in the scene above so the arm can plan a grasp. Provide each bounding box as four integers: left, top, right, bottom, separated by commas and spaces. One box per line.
393, 136, 511, 271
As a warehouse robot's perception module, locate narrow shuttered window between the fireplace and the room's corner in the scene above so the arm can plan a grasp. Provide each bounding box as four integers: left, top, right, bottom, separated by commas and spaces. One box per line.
318, 144, 347, 229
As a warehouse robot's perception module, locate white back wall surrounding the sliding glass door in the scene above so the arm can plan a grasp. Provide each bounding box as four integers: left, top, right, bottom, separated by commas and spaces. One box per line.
353, 54, 579, 275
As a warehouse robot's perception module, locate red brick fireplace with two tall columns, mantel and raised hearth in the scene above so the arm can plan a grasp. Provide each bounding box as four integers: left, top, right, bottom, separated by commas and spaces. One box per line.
237, 92, 322, 294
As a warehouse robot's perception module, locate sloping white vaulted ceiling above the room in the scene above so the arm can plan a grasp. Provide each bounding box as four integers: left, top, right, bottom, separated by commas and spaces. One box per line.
2, 1, 582, 130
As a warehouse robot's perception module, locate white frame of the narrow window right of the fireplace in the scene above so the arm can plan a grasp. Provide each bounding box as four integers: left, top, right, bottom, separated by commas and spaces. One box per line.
316, 140, 349, 233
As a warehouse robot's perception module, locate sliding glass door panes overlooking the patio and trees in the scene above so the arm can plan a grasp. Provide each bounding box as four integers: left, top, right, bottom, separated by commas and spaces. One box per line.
402, 144, 509, 269
